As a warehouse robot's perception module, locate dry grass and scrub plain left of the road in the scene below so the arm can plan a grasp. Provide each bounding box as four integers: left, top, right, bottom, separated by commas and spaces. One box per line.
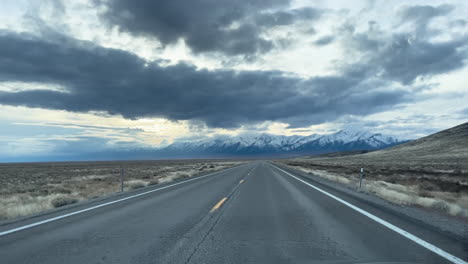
0, 160, 247, 220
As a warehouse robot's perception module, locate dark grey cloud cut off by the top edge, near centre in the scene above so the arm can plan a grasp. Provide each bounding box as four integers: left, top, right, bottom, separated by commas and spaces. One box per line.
100, 0, 321, 56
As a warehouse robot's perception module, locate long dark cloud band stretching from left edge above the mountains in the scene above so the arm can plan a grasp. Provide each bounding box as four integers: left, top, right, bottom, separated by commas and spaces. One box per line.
0, 32, 411, 127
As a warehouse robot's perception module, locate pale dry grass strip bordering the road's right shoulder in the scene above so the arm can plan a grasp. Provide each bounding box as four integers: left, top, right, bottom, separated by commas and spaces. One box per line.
288, 166, 468, 217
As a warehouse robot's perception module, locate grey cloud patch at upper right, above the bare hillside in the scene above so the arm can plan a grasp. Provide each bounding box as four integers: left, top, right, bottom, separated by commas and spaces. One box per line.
341, 5, 468, 85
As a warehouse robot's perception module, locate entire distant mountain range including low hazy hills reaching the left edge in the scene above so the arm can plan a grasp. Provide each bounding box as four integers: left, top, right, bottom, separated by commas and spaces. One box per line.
0, 129, 408, 162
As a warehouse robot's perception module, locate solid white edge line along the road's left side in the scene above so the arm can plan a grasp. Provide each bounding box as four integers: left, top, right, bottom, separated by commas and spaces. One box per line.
0, 165, 244, 237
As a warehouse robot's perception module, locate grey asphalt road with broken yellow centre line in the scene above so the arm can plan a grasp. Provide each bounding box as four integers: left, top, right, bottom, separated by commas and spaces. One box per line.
0, 161, 468, 264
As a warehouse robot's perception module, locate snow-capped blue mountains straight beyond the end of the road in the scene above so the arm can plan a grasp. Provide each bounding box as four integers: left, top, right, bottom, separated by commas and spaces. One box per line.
160, 129, 406, 157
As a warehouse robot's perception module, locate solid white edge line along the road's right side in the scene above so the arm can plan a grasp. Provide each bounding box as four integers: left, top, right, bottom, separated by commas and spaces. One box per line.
270, 164, 467, 264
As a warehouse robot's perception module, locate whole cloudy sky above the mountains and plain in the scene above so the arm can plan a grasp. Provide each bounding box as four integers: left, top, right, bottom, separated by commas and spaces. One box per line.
0, 0, 468, 161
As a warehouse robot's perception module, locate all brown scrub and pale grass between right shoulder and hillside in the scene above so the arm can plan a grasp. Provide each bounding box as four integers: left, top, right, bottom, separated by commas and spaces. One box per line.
278, 158, 468, 217
